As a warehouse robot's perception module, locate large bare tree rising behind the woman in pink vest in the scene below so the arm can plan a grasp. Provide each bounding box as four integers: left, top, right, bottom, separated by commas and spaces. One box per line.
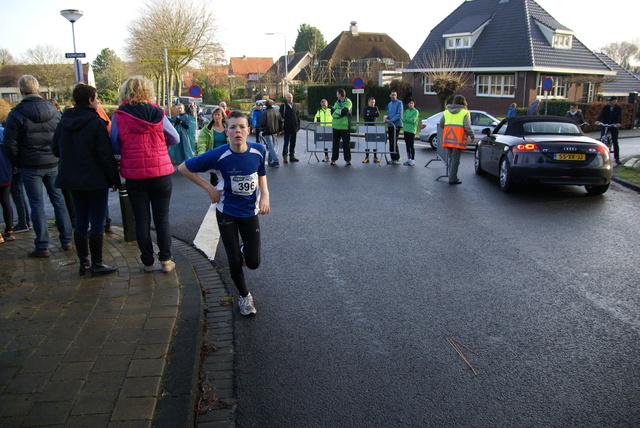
126, 0, 222, 104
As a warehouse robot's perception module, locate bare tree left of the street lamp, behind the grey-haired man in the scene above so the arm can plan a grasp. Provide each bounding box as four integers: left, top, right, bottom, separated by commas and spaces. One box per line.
22, 45, 75, 98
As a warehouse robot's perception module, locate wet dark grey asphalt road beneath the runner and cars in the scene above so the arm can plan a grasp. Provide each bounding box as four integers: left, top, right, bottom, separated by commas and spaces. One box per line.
101, 134, 640, 427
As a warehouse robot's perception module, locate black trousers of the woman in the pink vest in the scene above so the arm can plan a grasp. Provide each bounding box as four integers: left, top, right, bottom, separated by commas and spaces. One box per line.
125, 175, 172, 266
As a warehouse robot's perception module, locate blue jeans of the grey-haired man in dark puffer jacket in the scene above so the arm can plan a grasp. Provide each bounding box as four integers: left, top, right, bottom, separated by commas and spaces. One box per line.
21, 167, 71, 251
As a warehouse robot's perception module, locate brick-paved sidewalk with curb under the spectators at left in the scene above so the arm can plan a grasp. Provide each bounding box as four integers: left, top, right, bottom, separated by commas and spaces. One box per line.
0, 228, 233, 427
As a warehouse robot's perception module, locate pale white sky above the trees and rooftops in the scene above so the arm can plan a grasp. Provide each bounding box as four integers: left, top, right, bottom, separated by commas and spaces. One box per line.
0, 0, 640, 65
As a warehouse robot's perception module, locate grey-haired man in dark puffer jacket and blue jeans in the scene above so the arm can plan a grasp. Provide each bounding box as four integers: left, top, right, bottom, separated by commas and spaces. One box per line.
4, 74, 73, 257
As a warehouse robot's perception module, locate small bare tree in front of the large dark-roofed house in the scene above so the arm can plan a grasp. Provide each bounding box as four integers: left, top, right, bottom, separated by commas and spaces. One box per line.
416, 45, 470, 110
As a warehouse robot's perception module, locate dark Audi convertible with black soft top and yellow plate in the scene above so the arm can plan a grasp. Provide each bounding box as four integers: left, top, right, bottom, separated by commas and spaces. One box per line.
475, 116, 613, 195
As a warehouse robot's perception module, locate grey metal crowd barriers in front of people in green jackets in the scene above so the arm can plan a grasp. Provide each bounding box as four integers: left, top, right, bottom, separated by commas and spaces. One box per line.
305, 122, 398, 163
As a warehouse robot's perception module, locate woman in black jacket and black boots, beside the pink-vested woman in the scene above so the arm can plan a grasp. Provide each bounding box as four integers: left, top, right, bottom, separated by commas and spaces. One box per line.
51, 83, 120, 275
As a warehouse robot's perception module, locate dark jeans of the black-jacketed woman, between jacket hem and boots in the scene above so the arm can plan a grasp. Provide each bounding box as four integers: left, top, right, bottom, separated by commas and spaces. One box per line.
71, 189, 109, 236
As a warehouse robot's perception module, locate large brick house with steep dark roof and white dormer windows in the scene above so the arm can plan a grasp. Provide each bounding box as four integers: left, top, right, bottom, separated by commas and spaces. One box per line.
403, 0, 628, 114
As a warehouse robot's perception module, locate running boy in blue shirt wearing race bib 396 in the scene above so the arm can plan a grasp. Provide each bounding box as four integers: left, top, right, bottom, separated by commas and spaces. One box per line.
178, 111, 271, 315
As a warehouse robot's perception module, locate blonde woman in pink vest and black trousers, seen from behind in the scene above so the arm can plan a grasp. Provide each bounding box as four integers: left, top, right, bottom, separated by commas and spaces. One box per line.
111, 76, 180, 273
